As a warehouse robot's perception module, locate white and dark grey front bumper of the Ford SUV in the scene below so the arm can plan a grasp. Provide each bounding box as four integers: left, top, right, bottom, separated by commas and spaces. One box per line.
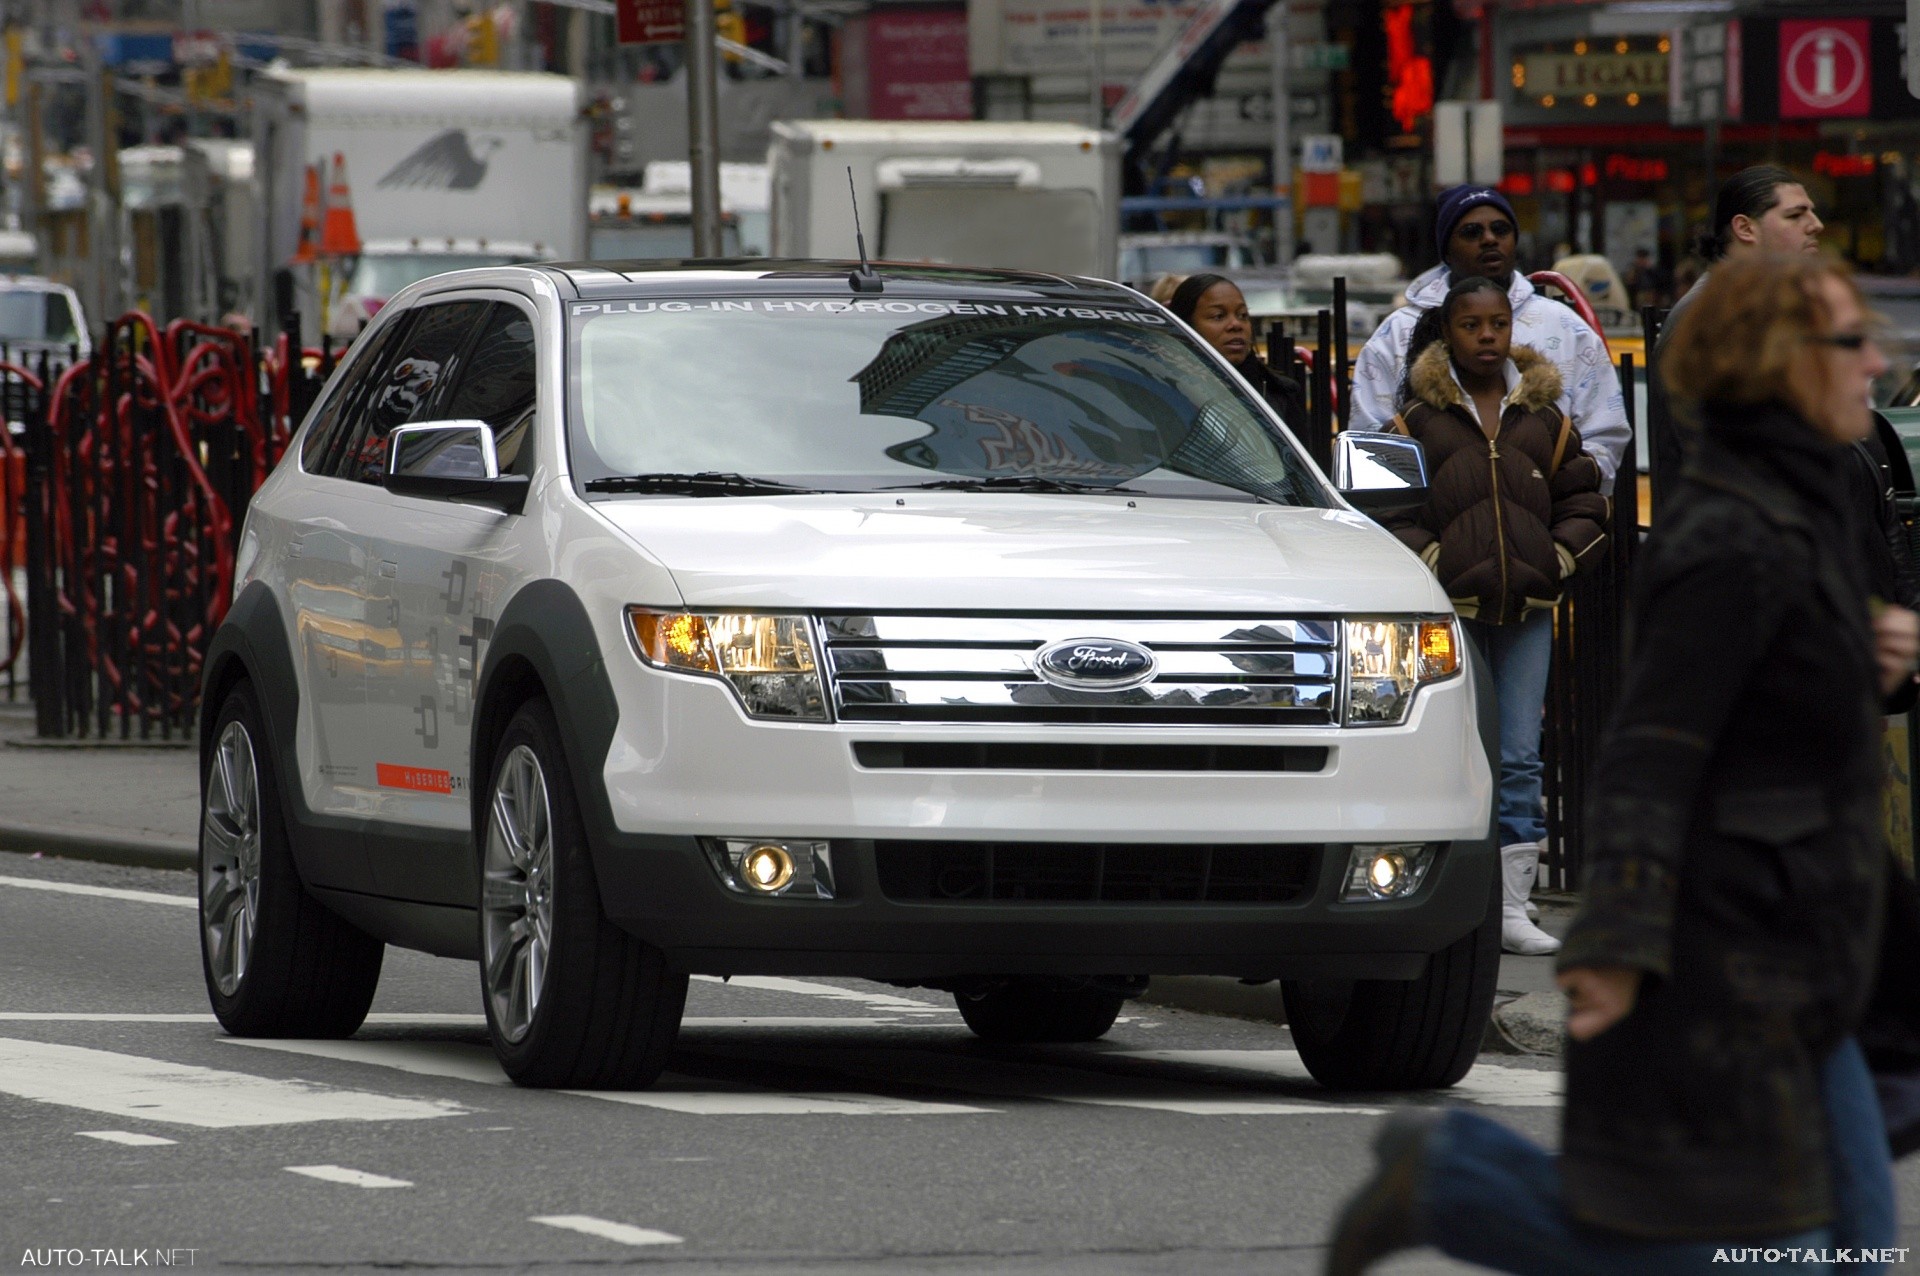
588, 662, 1496, 981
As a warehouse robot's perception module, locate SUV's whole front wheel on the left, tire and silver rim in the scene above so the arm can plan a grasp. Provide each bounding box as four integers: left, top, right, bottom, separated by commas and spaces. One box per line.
480, 698, 687, 1090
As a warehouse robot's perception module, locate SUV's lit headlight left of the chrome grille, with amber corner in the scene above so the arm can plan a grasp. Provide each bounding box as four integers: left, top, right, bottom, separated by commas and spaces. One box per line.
626, 606, 828, 721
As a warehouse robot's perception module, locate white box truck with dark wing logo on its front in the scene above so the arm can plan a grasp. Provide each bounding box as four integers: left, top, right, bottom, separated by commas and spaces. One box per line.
253, 69, 588, 338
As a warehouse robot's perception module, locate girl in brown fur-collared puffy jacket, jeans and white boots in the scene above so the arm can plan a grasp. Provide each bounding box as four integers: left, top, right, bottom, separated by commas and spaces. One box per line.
1388, 278, 1607, 954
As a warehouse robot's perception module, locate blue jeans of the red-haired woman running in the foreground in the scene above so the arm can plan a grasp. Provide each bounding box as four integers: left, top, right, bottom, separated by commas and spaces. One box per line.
1417, 1040, 1895, 1276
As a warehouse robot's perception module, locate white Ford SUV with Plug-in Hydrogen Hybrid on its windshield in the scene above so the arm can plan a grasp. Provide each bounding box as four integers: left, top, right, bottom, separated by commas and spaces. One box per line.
200, 261, 1498, 1088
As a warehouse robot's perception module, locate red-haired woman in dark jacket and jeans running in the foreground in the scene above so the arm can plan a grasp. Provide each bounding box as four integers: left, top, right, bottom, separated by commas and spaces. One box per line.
1329, 257, 1920, 1272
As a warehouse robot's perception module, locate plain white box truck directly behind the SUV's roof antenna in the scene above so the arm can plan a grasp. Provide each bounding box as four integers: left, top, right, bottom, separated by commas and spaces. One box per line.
768, 119, 1119, 278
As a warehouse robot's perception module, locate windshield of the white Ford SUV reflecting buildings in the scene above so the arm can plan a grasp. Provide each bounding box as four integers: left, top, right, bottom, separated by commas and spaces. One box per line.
570, 297, 1331, 507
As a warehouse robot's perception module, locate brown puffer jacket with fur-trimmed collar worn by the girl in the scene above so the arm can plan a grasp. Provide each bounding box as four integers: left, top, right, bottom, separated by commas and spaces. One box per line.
1386, 342, 1609, 626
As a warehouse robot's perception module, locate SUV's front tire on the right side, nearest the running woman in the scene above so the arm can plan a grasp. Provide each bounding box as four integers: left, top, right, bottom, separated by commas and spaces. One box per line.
1281, 873, 1500, 1090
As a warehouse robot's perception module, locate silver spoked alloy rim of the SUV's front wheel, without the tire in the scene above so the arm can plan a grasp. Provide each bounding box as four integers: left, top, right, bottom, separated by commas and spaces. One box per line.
480, 744, 553, 1042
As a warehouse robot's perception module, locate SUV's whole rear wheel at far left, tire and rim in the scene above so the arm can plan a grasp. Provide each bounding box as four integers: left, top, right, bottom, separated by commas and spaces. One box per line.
200, 681, 386, 1036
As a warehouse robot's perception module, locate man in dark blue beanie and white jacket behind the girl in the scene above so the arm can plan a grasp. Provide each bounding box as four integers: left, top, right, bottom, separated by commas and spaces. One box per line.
1354, 186, 1628, 489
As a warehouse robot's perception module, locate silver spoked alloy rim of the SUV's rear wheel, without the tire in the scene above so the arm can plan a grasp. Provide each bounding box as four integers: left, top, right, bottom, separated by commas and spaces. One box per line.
200, 721, 261, 996
